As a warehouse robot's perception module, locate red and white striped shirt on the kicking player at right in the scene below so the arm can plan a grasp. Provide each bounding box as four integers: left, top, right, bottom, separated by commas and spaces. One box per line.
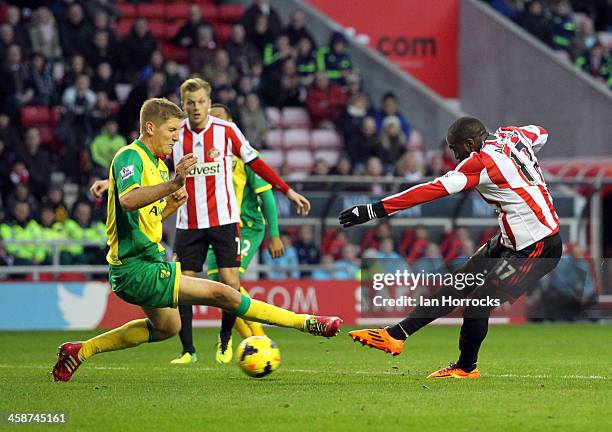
382, 125, 559, 250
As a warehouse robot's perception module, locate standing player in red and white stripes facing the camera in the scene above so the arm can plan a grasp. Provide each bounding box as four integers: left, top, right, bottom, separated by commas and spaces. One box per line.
172, 78, 310, 360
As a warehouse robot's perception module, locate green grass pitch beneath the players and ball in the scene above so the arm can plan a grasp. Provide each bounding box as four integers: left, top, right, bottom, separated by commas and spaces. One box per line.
0, 324, 612, 432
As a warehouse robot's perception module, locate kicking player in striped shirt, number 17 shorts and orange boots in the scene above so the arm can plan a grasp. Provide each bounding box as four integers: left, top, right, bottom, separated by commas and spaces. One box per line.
340, 117, 563, 378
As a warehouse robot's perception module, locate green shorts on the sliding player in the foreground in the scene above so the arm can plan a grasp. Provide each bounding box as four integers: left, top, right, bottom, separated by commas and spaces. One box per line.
108, 256, 181, 308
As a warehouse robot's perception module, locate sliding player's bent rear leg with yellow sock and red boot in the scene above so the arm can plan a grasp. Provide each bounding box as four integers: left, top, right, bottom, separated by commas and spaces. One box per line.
52, 308, 181, 381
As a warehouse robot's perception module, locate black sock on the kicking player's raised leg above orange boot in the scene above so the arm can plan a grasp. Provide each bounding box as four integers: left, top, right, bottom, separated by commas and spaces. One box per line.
387, 287, 463, 340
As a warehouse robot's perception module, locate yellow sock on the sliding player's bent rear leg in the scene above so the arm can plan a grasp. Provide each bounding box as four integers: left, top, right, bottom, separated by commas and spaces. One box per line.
79, 319, 155, 361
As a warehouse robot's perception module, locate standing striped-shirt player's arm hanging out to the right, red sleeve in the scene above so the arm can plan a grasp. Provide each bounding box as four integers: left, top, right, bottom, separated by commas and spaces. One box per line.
229, 124, 310, 216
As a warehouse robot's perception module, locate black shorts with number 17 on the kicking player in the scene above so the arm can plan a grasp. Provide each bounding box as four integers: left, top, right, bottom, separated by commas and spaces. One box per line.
453, 233, 563, 302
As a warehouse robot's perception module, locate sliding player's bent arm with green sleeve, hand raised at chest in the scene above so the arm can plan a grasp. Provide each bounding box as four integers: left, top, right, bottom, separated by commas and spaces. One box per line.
119, 152, 197, 211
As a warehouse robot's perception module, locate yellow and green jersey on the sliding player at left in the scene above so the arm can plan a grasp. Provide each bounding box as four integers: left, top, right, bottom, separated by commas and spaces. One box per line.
106, 140, 169, 265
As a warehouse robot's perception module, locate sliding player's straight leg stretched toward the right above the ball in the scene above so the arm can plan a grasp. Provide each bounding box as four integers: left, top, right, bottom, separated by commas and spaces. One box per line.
179, 276, 342, 337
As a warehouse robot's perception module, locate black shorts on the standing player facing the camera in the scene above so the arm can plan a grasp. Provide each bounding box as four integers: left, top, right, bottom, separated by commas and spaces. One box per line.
174, 223, 240, 272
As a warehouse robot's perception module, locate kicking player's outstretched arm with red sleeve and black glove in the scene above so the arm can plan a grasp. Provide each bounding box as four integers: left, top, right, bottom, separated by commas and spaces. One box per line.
339, 153, 486, 228
